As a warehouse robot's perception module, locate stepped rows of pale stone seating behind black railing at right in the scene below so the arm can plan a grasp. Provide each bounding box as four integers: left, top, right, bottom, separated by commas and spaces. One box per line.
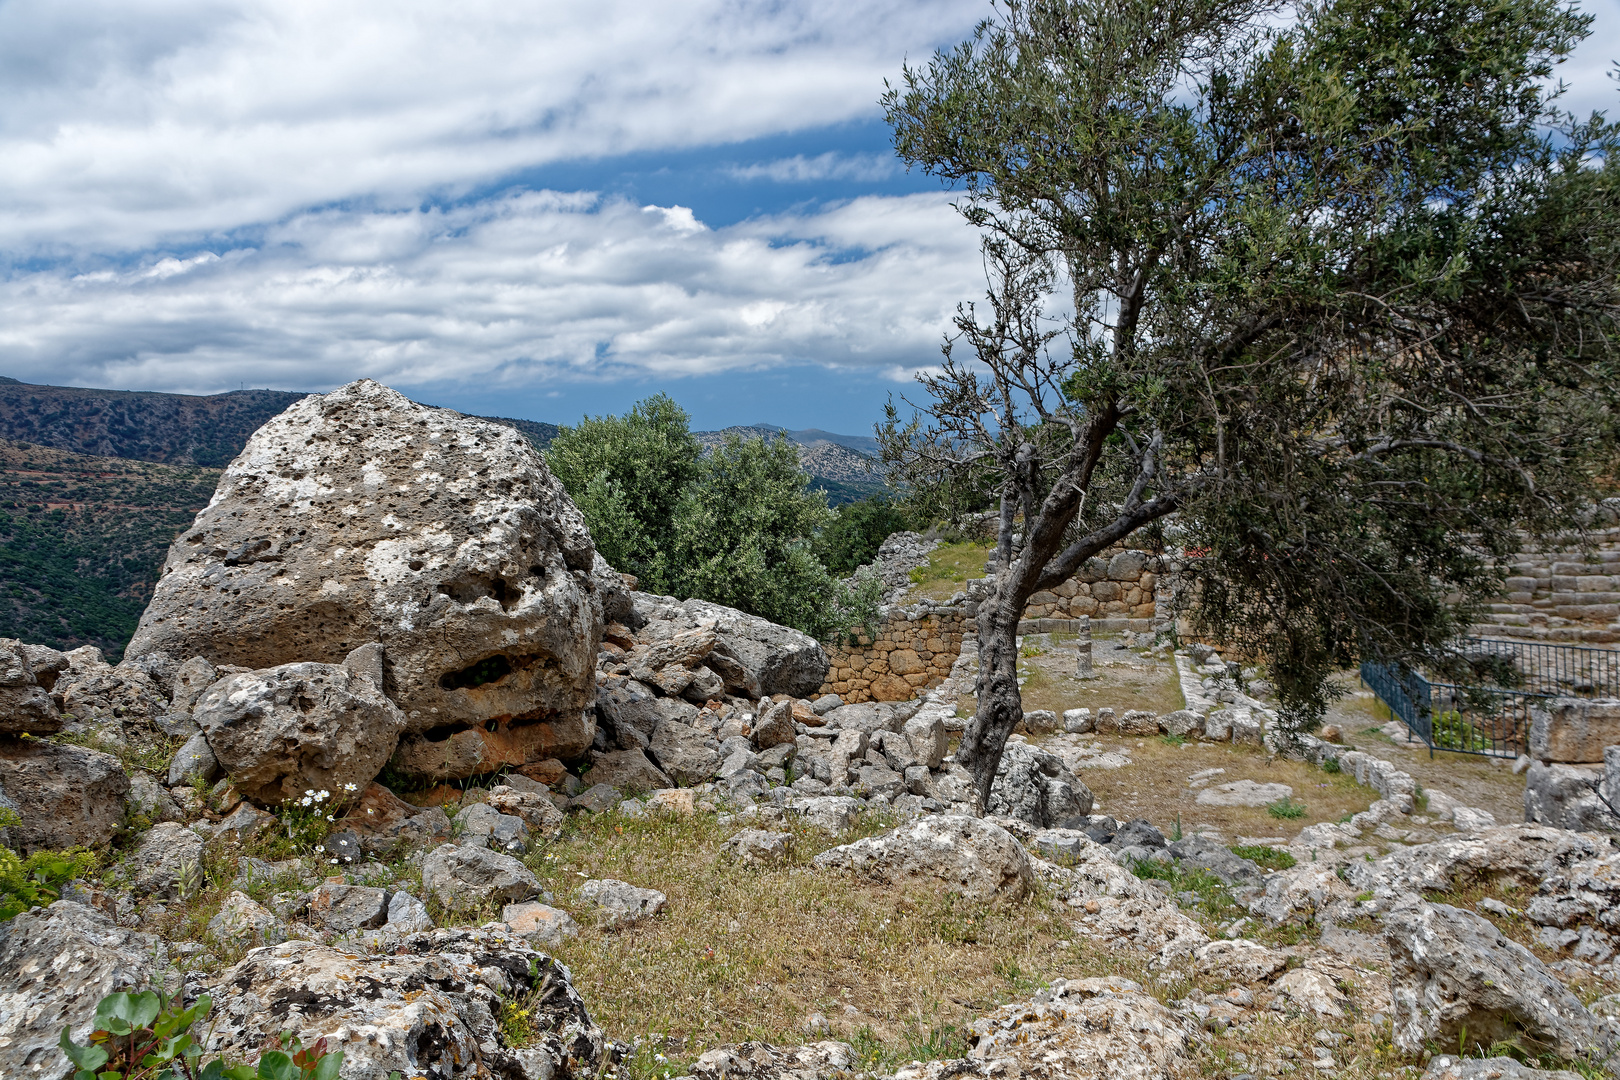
1473, 529, 1620, 644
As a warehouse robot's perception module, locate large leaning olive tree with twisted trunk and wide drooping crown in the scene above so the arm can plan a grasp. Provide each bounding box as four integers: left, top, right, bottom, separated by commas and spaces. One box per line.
881, 0, 1620, 805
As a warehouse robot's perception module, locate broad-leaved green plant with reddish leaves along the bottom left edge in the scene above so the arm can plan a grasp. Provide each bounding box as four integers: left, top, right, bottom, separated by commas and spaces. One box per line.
58, 989, 343, 1080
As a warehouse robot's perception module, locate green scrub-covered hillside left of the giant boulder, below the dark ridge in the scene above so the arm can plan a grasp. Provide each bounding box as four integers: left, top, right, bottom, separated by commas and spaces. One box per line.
0, 440, 220, 657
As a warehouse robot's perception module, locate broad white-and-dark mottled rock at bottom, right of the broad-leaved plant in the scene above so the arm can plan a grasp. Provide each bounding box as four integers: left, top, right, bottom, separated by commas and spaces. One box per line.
207, 928, 608, 1080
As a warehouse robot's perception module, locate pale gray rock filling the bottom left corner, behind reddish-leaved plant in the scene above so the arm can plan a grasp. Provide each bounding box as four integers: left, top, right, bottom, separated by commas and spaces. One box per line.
0, 900, 167, 1080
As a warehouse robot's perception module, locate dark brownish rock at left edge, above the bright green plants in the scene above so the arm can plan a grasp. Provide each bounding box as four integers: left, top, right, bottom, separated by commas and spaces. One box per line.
0, 738, 130, 855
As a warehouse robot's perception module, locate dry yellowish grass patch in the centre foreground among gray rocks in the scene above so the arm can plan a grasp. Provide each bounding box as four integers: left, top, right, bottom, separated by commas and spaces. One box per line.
511, 814, 1111, 1061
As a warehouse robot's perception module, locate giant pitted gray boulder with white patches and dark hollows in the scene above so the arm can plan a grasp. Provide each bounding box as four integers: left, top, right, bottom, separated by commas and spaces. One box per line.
128, 379, 603, 779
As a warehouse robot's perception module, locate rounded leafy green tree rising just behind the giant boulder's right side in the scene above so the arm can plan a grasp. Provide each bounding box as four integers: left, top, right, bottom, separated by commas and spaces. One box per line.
546, 393, 703, 588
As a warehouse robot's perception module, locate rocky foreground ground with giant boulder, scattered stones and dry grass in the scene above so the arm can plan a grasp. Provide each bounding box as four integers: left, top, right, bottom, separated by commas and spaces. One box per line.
0, 384, 1620, 1080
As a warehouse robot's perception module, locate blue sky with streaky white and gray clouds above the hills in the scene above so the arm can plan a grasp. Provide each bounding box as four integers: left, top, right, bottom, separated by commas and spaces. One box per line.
0, 0, 1620, 434
